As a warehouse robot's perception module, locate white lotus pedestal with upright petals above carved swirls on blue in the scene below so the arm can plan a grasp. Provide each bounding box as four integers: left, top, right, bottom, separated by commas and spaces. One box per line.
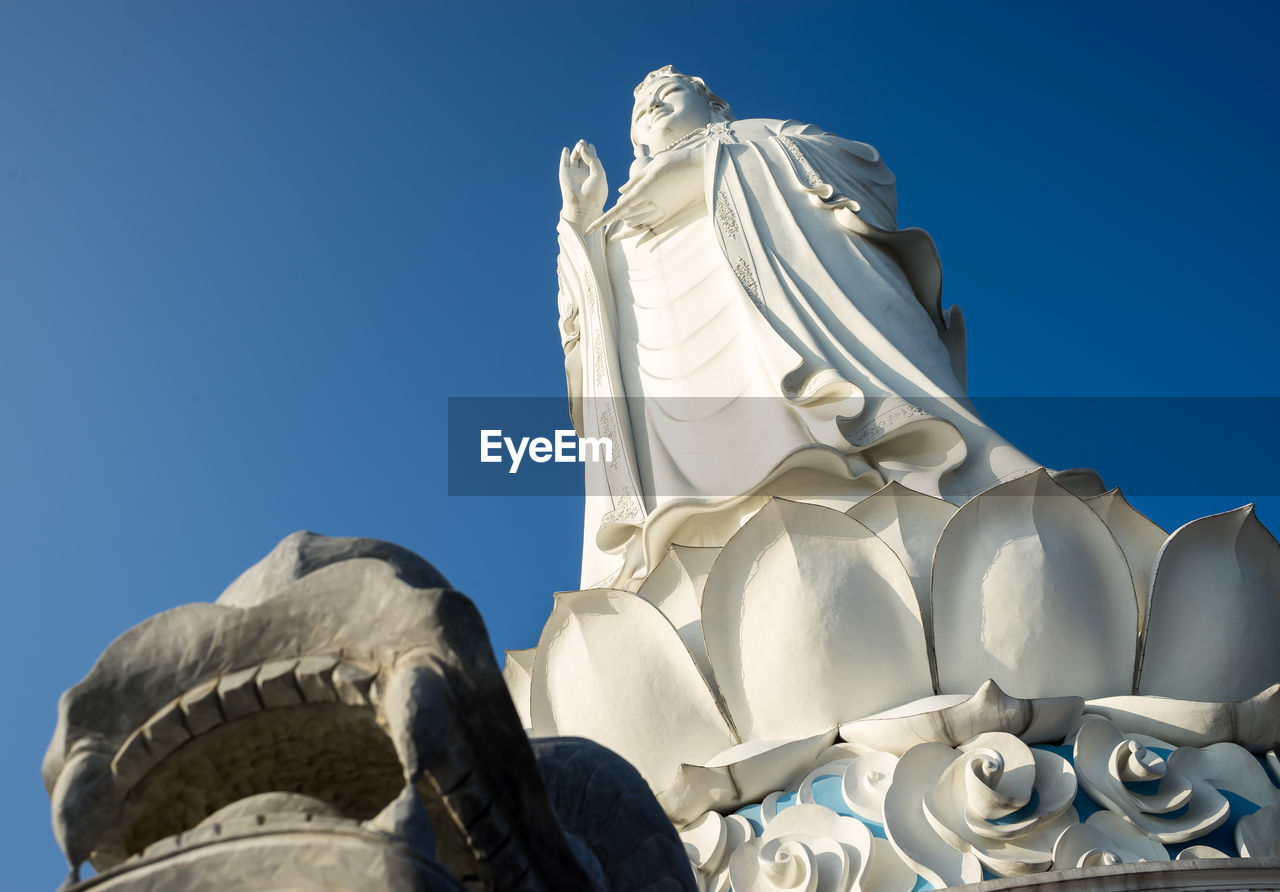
506, 471, 1280, 892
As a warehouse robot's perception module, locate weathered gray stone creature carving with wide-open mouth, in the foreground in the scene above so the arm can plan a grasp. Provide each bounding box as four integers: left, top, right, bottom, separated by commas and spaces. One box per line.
44, 532, 695, 892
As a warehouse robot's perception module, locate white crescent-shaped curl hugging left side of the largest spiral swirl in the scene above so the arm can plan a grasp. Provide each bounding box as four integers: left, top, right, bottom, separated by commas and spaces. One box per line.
884, 744, 982, 888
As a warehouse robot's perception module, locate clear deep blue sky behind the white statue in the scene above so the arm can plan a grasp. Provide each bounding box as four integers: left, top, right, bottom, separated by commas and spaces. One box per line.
0, 0, 1280, 889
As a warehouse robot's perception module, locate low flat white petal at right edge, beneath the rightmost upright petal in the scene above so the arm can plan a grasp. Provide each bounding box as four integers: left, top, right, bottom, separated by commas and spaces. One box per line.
1084, 685, 1280, 754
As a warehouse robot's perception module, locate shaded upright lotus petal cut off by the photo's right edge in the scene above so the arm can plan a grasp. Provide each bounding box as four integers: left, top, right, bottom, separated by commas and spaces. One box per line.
1138, 506, 1280, 700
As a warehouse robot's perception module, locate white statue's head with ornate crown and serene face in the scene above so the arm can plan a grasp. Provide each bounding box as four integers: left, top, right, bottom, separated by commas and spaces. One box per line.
631, 65, 733, 159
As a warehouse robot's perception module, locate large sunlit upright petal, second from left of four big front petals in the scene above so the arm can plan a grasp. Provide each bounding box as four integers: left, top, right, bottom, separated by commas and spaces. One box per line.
703, 499, 932, 740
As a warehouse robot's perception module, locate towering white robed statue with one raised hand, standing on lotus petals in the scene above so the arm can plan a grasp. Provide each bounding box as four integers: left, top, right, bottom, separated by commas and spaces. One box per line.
558, 65, 1075, 589
